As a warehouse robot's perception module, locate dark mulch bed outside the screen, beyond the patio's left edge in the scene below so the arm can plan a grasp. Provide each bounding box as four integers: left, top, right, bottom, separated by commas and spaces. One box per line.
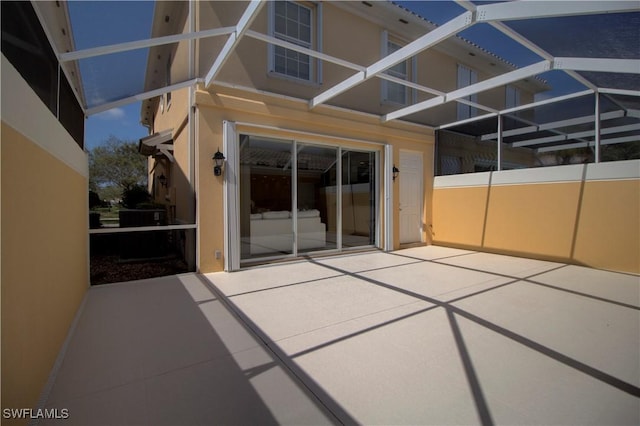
91, 255, 189, 285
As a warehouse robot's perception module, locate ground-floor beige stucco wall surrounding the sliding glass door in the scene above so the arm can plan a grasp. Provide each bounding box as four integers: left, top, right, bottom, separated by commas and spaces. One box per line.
196, 88, 433, 272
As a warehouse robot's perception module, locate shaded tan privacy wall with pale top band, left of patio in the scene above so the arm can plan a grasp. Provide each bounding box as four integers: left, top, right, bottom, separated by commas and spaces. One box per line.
1, 55, 88, 418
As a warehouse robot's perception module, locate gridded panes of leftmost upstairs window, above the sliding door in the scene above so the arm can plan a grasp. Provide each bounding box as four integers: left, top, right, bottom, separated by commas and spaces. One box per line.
270, 1, 313, 81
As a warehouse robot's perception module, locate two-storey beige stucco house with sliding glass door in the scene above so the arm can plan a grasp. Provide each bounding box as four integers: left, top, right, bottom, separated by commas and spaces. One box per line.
141, 1, 547, 272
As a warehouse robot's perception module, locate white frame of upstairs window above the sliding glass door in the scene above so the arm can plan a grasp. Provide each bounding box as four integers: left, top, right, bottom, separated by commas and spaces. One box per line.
267, 0, 322, 84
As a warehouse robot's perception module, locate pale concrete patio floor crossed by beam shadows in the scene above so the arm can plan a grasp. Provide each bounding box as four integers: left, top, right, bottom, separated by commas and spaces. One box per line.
41, 246, 640, 425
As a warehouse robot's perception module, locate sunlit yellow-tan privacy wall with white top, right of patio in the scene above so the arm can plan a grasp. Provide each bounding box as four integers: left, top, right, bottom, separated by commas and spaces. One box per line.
433, 160, 640, 273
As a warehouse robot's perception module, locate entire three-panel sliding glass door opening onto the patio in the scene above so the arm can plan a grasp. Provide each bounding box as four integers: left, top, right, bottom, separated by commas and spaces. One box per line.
238, 135, 377, 262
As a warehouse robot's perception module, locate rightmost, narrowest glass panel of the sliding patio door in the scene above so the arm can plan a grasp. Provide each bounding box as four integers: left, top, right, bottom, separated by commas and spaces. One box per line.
342, 151, 376, 248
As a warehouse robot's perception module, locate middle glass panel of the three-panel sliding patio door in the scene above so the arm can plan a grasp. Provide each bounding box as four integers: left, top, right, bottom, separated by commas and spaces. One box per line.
296, 144, 338, 253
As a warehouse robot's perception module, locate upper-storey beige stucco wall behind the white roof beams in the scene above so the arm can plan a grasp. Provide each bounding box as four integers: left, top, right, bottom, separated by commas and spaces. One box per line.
190, 2, 533, 124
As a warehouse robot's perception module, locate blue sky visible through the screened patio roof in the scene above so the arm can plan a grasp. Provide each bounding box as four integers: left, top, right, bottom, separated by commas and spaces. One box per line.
69, 1, 581, 149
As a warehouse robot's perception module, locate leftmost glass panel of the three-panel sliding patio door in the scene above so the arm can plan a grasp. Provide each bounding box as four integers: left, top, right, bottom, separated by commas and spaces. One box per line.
239, 135, 293, 260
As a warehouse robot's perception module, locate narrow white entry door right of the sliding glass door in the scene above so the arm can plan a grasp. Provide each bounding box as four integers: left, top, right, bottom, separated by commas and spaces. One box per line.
398, 150, 424, 244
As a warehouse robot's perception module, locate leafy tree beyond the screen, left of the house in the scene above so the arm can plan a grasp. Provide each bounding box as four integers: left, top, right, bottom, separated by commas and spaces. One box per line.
89, 136, 147, 200
